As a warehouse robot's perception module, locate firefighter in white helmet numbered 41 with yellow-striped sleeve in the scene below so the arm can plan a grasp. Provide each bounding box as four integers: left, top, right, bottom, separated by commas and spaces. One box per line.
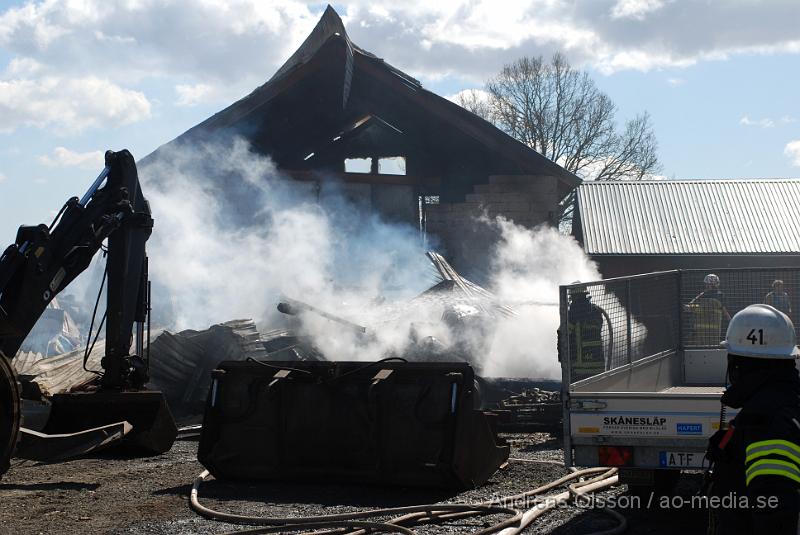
707, 304, 800, 535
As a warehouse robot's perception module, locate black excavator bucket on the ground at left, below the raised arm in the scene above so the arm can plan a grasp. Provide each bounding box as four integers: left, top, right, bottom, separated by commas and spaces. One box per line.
42, 390, 178, 455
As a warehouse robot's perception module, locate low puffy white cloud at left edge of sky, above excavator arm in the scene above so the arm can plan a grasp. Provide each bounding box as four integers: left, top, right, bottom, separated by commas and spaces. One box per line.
0, 76, 150, 133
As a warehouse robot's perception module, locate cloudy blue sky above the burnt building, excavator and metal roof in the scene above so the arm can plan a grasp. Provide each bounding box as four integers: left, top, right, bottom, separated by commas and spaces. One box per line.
0, 0, 800, 243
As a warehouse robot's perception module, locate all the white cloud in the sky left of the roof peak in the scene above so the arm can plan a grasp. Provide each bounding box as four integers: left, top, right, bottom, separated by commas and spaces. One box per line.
0, 0, 323, 132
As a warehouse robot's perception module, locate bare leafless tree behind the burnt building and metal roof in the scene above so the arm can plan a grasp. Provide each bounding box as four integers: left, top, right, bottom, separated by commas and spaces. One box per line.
472, 54, 660, 226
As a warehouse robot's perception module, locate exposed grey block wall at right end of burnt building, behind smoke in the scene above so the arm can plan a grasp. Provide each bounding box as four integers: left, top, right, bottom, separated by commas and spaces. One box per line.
425, 175, 560, 280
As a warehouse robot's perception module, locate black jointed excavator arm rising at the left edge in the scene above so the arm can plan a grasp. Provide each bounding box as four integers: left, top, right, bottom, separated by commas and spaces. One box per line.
0, 150, 174, 474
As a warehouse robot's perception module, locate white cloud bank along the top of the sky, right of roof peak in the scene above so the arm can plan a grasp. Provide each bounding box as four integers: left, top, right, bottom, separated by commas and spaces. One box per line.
345, 0, 800, 81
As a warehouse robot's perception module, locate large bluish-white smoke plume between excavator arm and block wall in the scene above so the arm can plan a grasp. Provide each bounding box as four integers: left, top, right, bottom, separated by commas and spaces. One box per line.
140, 139, 428, 336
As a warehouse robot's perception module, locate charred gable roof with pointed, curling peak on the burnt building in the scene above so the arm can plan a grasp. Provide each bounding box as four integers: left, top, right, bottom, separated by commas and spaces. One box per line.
150, 6, 580, 188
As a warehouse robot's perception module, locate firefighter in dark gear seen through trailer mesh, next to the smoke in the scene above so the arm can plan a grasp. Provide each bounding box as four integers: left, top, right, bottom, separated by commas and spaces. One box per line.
568, 289, 606, 381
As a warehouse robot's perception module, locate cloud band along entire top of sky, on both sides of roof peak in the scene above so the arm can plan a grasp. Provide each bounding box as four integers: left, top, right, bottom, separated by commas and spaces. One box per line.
0, 0, 800, 101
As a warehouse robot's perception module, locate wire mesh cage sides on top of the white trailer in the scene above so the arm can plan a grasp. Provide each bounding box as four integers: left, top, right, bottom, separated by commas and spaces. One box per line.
560, 268, 800, 382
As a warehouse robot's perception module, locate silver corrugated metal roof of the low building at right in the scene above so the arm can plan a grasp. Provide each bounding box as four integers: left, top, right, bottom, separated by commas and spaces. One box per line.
578, 180, 800, 255
